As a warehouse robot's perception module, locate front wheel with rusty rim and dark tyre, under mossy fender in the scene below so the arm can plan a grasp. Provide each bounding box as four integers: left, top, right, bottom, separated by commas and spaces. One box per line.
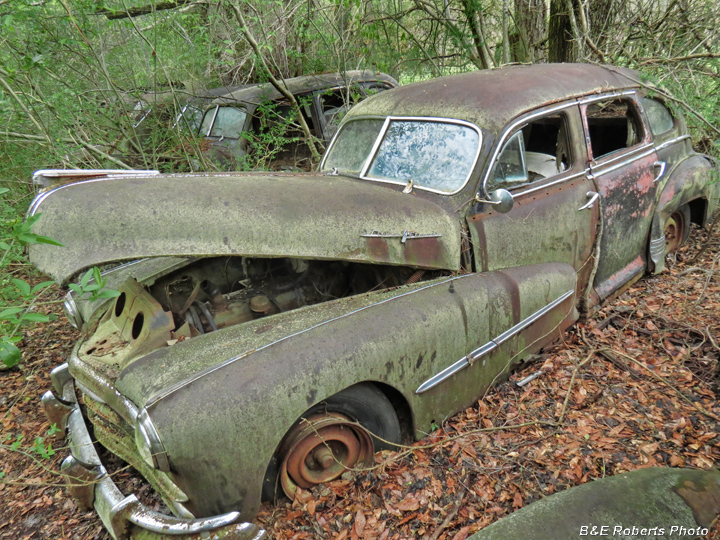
278, 383, 401, 499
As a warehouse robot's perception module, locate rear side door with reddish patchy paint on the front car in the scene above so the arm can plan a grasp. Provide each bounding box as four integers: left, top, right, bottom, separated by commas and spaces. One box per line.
580, 92, 663, 300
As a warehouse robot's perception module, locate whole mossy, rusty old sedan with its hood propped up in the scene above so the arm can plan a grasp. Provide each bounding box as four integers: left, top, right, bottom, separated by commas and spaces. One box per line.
30, 64, 718, 538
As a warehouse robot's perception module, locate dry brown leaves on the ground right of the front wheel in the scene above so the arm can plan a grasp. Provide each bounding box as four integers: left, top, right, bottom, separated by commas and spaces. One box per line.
256, 226, 720, 540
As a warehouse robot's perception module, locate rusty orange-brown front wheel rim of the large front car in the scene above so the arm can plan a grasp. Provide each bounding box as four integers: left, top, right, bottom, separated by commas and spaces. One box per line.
280, 413, 373, 499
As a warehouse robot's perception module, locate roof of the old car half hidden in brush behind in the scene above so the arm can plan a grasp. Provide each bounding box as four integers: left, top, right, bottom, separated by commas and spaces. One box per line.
211, 70, 398, 106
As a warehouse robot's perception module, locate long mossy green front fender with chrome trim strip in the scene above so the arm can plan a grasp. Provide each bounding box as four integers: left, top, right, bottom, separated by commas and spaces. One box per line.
101, 264, 577, 518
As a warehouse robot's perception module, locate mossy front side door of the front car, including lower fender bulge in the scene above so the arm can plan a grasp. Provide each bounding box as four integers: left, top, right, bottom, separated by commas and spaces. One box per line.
452, 102, 599, 384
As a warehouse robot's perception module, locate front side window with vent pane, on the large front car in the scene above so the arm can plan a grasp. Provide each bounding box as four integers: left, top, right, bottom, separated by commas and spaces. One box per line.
488, 114, 573, 191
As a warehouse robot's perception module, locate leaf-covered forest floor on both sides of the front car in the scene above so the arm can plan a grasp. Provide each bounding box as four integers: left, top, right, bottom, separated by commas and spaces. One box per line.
0, 227, 720, 540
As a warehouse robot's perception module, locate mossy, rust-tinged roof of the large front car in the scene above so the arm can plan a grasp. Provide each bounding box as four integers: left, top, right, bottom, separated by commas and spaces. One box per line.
346, 64, 640, 133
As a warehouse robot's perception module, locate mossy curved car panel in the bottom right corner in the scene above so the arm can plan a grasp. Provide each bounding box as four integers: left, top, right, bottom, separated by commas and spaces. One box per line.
470, 468, 720, 540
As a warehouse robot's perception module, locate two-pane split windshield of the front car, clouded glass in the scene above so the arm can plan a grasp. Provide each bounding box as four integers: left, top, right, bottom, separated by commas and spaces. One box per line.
323, 118, 480, 193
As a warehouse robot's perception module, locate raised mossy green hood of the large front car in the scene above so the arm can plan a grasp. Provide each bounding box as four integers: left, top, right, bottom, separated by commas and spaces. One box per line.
29, 173, 460, 283
